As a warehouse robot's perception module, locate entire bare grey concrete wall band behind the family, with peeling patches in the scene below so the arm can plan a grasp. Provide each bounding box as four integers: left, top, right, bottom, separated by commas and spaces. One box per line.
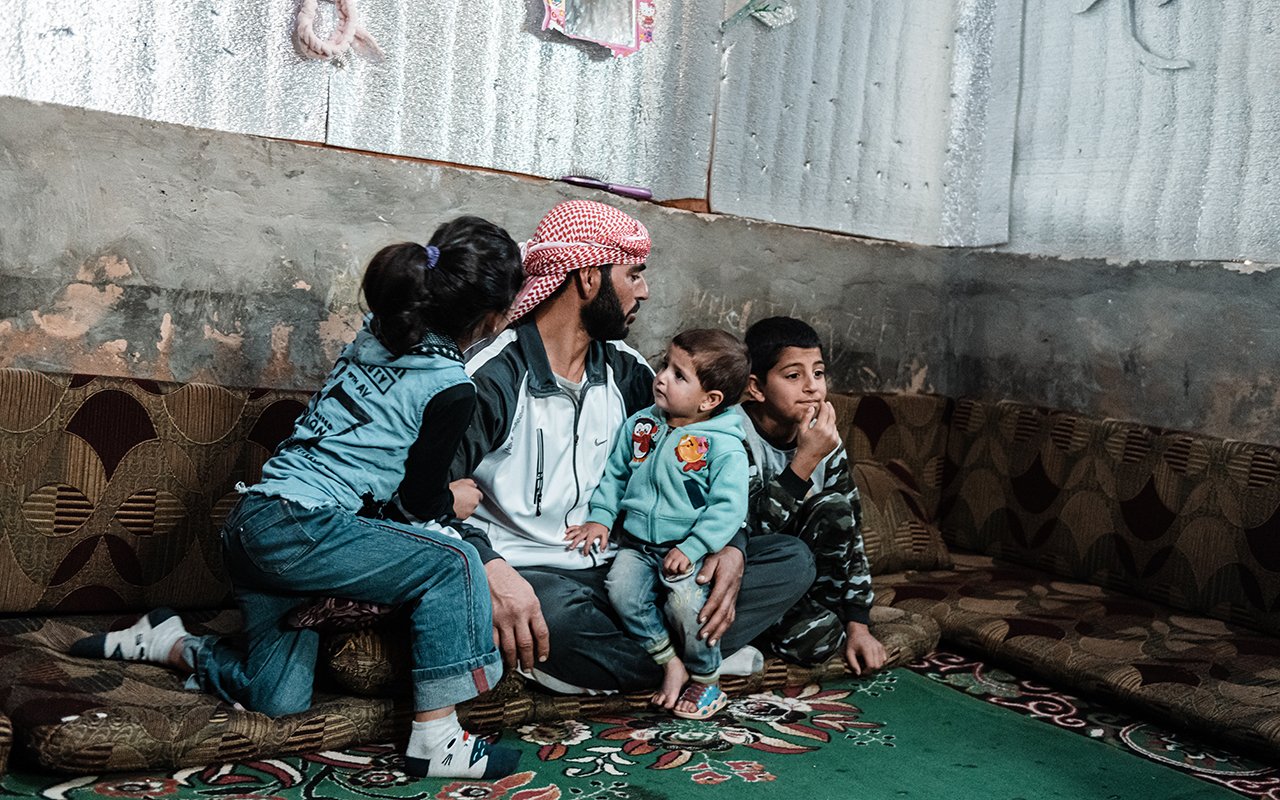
0, 99, 1280, 443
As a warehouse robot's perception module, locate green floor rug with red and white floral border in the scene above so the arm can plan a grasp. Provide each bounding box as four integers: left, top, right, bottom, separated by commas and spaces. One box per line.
0, 669, 1236, 800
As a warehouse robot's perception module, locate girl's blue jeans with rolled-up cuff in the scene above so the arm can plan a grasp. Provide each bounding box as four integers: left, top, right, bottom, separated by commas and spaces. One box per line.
188, 494, 502, 717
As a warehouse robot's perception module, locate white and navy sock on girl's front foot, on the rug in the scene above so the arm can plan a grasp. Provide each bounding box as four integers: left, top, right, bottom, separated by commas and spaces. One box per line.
404, 712, 520, 778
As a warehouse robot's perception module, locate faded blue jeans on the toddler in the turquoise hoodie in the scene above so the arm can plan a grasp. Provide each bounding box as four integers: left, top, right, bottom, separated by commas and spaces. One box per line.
604, 541, 721, 682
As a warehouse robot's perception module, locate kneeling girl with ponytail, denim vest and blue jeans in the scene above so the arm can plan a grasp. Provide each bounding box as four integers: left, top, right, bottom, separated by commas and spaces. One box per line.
72, 216, 524, 778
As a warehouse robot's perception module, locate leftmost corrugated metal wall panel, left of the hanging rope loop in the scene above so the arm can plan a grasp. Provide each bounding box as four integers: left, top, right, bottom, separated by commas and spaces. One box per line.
0, 0, 330, 141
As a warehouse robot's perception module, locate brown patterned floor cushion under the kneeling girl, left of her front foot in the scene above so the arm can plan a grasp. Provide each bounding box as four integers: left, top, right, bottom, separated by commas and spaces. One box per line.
0, 612, 408, 773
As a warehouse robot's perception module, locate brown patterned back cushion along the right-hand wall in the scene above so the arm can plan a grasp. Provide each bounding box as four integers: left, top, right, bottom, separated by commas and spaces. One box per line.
942, 401, 1280, 634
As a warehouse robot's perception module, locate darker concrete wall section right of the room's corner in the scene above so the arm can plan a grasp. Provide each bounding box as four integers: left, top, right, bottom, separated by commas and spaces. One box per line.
938, 251, 1280, 443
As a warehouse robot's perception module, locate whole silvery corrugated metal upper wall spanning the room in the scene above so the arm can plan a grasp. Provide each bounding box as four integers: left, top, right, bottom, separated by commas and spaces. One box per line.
0, 0, 1280, 262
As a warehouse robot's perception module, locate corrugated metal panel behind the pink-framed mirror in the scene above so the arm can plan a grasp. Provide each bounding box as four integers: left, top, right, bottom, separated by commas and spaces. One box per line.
328, 0, 721, 198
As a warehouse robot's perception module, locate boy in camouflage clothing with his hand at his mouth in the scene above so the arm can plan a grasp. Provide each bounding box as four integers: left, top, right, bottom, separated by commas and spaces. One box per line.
740, 316, 886, 675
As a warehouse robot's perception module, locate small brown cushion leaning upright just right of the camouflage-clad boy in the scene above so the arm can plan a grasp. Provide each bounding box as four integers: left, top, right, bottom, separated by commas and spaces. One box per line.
854, 461, 951, 575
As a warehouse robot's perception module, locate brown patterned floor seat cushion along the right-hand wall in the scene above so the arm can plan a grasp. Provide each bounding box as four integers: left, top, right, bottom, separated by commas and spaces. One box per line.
877, 553, 1280, 760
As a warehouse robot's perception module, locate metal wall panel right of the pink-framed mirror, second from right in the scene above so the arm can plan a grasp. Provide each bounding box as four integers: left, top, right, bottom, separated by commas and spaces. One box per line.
710, 0, 1020, 244
